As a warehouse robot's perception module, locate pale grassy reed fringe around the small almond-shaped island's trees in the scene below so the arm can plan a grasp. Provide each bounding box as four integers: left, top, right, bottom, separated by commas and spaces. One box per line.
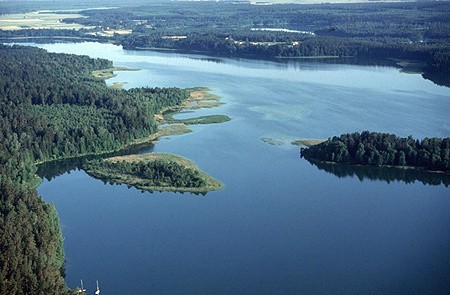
86, 153, 224, 194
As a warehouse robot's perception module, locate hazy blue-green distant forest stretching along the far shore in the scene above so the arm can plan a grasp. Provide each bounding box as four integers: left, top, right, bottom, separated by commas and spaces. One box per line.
0, 1, 450, 75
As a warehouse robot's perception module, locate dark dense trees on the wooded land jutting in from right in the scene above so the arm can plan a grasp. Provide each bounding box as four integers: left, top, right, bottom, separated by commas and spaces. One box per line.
300, 131, 450, 172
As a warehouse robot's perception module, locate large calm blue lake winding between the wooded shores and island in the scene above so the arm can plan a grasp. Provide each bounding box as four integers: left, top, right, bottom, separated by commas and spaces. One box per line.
36, 43, 450, 294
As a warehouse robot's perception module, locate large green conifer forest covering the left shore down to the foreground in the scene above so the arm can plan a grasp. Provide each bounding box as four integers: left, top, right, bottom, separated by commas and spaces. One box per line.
0, 45, 189, 294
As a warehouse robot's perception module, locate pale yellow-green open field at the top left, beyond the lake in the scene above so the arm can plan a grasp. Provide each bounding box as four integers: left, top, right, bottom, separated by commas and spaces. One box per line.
0, 10, 92, 30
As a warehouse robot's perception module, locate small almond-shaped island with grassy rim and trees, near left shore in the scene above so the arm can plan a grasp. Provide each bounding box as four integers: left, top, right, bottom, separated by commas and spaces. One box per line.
84, 153, 223, 194
